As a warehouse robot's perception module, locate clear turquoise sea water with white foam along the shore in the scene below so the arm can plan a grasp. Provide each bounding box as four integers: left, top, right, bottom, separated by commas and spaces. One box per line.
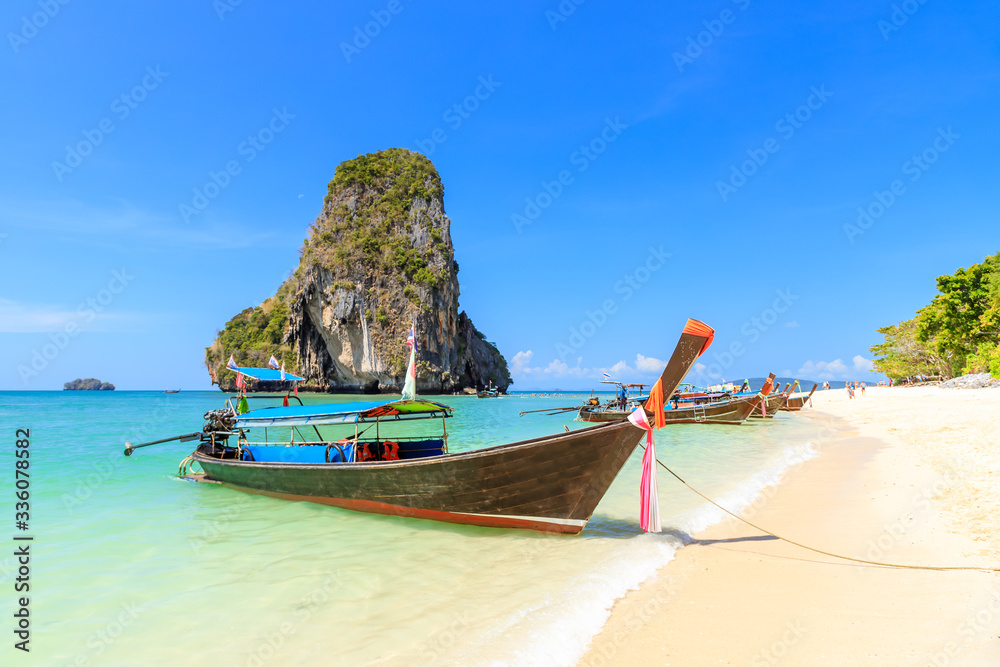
0, 391, 813, 666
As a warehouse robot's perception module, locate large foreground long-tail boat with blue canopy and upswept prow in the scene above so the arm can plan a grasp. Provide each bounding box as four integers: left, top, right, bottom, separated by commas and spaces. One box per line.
125, 320, 714, 534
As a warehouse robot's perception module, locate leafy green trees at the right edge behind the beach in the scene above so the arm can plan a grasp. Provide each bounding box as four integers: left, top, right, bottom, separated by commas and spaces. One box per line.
871, 253, 1000, 379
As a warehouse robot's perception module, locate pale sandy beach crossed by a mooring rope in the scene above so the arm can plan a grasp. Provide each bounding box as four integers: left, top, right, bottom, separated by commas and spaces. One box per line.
580, 387, 1000, 665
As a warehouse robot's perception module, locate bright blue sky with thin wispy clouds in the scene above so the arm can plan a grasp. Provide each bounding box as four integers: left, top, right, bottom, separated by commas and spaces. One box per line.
0, 0, 1000, 390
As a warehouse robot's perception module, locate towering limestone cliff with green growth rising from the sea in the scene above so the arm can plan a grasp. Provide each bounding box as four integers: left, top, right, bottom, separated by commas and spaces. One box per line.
206, 148, 511, 393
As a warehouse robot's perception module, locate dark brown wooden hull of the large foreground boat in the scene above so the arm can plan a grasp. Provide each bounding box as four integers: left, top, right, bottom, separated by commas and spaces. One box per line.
192, 421, 644, 534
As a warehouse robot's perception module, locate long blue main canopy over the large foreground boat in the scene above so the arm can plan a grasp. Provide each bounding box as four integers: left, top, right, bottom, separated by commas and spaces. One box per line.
236, 399, 453, 428
